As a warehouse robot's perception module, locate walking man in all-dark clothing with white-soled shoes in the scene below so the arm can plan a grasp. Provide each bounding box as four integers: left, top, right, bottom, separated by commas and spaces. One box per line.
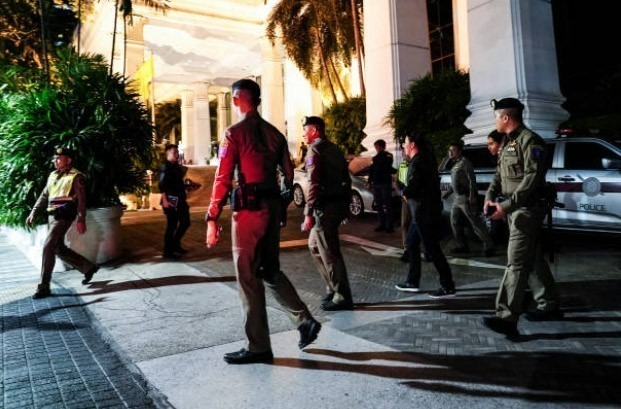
397, 133, 455, 298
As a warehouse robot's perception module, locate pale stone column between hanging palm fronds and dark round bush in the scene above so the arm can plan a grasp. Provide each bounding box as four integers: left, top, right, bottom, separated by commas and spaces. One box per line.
362, 0, 431, 155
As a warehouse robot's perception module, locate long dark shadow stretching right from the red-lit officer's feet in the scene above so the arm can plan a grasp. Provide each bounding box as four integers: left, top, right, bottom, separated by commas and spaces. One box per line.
284, 349, 621, 404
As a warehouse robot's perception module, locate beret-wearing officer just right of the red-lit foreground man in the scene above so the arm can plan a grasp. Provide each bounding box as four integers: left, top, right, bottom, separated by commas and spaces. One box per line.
302, 116, 353, 311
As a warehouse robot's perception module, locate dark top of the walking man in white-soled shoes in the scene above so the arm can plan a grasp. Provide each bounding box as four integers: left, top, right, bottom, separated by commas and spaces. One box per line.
403, 153, 442, 224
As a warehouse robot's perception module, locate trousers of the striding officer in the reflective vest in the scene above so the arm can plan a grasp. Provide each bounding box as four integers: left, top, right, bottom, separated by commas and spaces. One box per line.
39, 216, 95, 289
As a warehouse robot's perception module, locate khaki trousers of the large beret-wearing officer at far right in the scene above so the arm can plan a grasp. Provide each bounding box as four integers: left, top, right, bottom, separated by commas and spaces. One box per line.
496, 206, 558, 322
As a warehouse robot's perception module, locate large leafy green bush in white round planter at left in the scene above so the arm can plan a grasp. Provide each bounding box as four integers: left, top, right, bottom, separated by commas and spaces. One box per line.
0, 50, 154, 262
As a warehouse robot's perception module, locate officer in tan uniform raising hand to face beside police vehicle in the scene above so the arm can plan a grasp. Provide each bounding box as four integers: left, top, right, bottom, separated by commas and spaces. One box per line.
442, 142, 494, 257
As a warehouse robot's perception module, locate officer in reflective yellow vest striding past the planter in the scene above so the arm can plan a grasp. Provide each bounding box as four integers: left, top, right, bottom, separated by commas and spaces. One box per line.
26, 147, 98, 299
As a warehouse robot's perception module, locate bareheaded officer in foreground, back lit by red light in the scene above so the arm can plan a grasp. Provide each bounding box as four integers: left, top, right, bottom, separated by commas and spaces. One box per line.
205, 79, 321, 364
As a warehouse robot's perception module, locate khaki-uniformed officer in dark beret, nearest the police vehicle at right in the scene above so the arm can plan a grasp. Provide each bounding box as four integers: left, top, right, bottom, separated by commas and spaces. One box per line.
483, 98, 562, 337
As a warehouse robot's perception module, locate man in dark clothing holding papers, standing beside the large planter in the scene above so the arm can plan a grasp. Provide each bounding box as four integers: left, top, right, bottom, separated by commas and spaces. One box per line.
159, 144, 190, 259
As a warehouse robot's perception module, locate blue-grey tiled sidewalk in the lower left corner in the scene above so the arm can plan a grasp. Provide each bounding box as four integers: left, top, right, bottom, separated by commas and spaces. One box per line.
0, 233, 160, 409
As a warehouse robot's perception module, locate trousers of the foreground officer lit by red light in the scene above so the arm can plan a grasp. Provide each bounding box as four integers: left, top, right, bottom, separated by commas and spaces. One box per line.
231, 199, 311, 353
